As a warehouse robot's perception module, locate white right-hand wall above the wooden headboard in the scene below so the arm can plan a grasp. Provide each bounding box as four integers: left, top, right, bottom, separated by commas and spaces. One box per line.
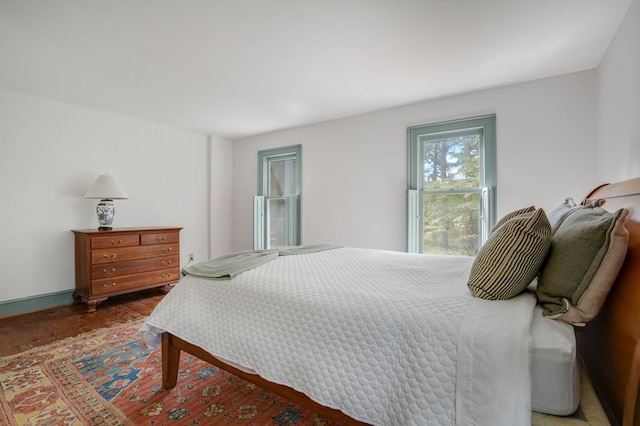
597, 0, 640, 182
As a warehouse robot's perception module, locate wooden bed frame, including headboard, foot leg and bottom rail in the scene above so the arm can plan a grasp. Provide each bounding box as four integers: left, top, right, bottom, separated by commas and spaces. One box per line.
162, 178, 640, 426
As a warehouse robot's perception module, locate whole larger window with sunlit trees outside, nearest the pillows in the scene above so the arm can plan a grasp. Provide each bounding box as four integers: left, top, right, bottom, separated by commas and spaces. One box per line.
407, 115, 496, 255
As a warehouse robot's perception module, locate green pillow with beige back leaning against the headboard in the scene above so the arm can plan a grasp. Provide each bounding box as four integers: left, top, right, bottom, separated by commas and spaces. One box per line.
536, 200, 629, 325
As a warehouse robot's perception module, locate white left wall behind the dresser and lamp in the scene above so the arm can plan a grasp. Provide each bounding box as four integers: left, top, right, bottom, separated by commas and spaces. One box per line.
0, 91, 222, 302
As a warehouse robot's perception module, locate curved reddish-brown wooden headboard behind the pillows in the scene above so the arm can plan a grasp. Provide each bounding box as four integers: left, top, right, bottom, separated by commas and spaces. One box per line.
576, 178, 640, 426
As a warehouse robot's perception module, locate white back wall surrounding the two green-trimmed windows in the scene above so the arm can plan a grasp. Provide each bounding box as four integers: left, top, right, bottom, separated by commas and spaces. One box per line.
232, 70, 597, 250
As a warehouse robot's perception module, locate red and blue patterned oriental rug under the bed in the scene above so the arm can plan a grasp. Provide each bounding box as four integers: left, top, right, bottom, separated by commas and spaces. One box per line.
0, 320, 340, 426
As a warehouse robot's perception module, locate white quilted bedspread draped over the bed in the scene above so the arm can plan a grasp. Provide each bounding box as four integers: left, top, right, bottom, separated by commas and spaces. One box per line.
142, 248, 535, 425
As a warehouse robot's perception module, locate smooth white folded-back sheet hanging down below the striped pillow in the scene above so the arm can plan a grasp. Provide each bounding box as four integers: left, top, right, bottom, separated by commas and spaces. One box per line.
456, 292, 536, 426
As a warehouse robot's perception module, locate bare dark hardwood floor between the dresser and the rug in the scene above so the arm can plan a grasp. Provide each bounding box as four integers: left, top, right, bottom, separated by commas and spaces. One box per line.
0, 289, 164, 356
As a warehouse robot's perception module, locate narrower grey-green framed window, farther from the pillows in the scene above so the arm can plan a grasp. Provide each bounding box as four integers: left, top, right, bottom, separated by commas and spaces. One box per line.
253, 145, 302, 250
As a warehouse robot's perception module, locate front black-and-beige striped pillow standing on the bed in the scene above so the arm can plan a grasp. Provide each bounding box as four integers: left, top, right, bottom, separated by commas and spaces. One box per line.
467, 209, 551, 300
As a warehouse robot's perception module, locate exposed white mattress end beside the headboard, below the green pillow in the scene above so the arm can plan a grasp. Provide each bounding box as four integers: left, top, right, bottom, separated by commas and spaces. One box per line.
531, 306, 580, 416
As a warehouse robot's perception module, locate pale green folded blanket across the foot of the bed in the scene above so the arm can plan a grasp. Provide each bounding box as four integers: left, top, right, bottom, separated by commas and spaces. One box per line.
182, 244, 340, 280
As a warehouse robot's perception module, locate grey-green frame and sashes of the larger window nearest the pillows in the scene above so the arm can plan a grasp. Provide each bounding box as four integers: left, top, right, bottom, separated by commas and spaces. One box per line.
406, 114, 497, 253
